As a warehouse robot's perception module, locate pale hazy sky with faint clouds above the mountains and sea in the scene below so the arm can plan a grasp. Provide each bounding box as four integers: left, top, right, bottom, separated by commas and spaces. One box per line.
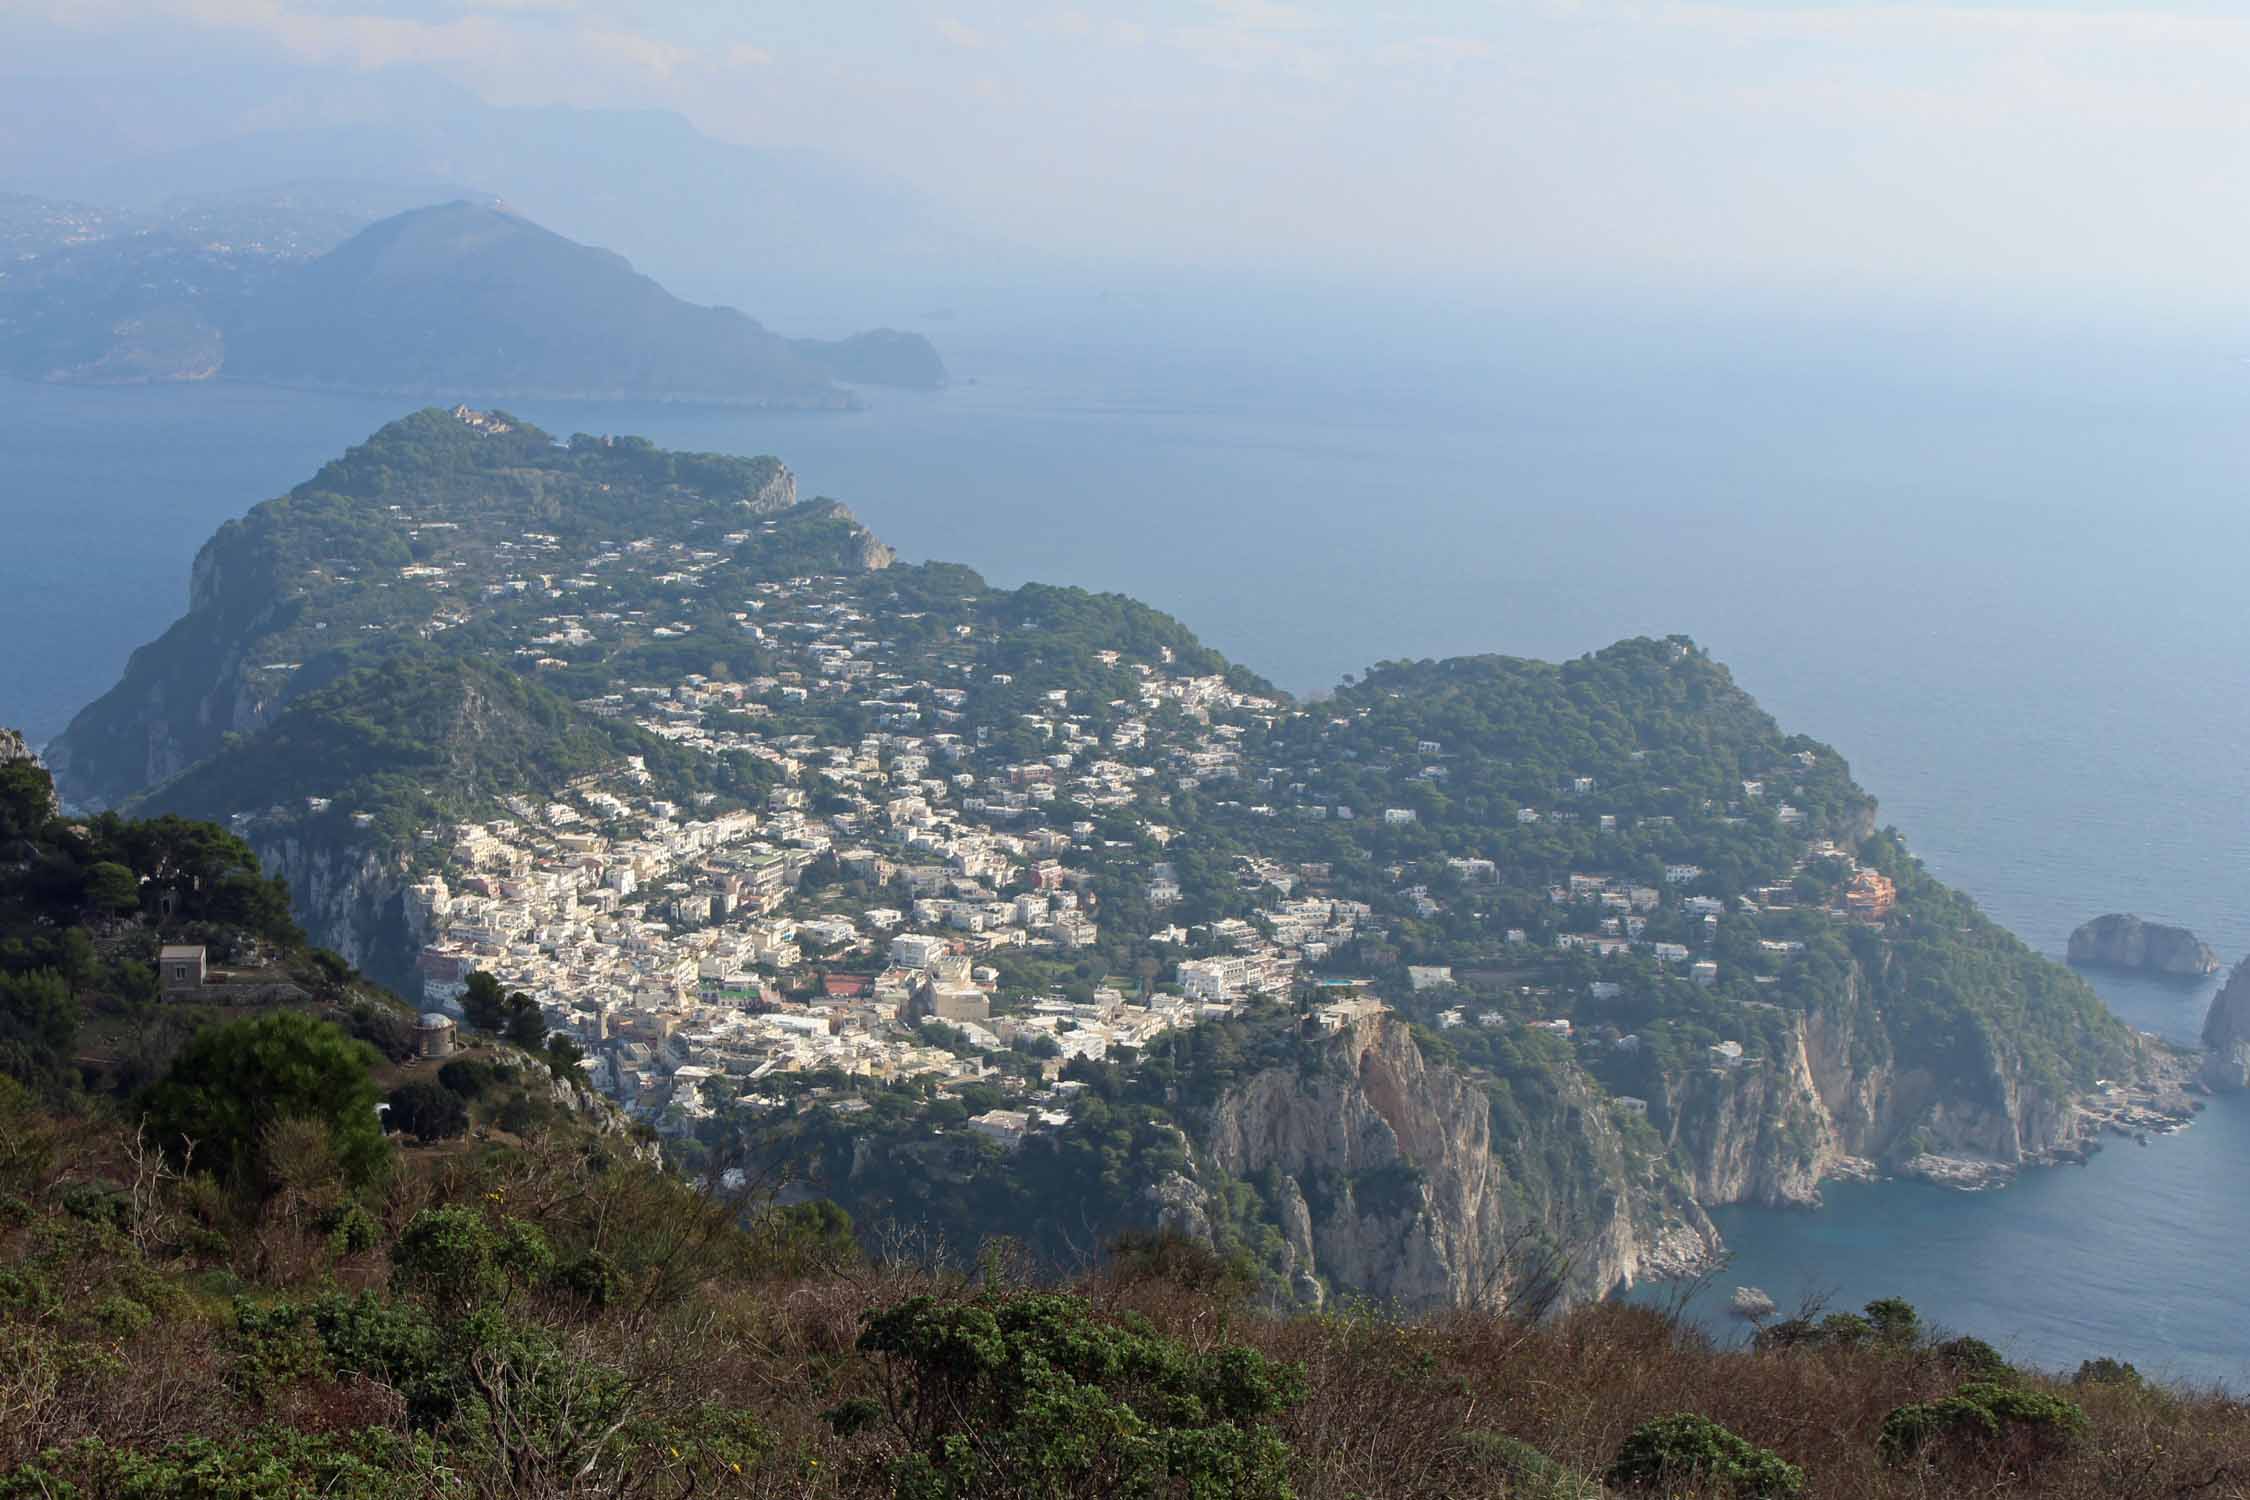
0, 0, 2250, 310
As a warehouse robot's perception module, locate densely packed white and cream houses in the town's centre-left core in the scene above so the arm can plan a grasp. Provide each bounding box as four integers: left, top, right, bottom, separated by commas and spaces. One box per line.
407, 558, 1395, 1140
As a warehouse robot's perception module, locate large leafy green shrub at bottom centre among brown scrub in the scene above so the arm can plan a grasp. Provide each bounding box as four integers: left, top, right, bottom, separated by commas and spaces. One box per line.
828, 1293, 1305, 1500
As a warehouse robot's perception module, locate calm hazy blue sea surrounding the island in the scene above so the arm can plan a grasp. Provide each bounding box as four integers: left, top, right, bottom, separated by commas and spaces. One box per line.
0, 304, 2250, 1390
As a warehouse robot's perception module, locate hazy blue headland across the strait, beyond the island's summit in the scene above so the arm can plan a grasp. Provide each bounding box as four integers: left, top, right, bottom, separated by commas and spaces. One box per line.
0, 200, 945, 409
